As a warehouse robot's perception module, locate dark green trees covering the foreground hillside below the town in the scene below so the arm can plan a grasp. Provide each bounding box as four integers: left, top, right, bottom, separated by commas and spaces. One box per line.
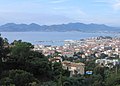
0, 37, 120, 86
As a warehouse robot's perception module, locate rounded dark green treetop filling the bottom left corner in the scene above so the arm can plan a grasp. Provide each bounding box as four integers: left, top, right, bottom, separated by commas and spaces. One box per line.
0, 70, 38, 86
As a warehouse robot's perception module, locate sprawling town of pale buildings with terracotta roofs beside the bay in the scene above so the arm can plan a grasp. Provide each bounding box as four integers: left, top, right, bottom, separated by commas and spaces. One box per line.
33, 36, 120, 76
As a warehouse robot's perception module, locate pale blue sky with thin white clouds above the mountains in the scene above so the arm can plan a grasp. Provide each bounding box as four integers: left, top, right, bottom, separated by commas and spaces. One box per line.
0, 0, 120, 26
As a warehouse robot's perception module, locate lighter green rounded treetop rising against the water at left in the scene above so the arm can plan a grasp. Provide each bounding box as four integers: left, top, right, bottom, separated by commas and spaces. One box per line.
11, 41, 33, 62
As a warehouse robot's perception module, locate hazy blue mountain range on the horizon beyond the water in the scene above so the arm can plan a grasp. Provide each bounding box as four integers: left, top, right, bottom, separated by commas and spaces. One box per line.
0, 23, 120, 32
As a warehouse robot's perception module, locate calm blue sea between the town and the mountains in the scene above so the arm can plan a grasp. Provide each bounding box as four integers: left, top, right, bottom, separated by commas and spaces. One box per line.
0, 32, 119, 46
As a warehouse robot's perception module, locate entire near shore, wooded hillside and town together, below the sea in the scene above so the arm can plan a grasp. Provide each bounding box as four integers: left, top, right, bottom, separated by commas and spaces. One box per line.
0, 36, 120, 86
